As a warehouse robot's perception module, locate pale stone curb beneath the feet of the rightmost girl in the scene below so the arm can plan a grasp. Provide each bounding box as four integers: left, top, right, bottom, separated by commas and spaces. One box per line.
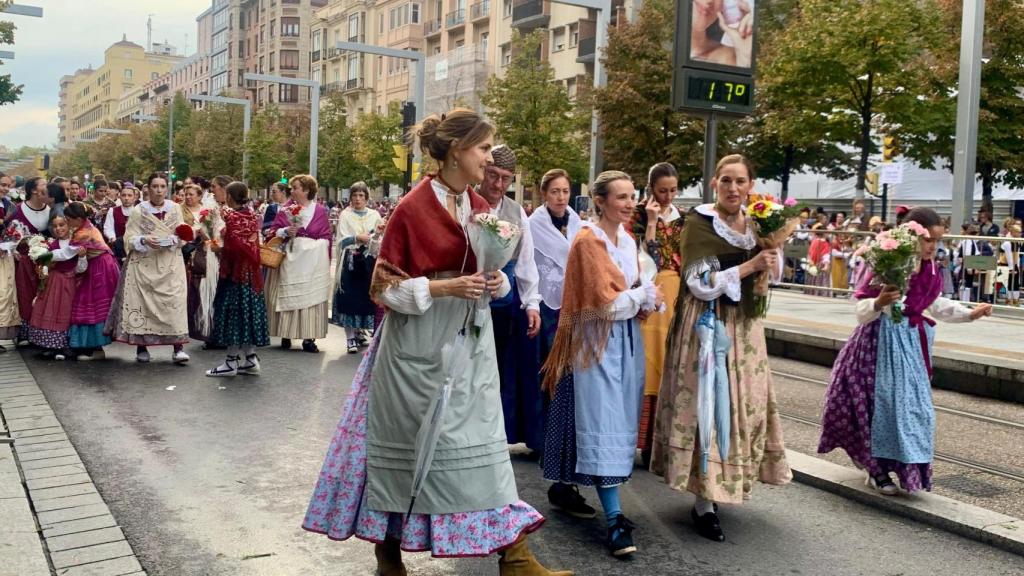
785, 450, 1024, 556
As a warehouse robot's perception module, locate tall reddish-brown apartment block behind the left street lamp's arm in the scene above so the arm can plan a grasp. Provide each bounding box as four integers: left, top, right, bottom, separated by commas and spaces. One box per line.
231, 0, 328, 111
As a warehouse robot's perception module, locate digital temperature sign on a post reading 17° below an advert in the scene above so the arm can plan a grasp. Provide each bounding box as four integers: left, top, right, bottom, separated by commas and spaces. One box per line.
672, 0, 757, 202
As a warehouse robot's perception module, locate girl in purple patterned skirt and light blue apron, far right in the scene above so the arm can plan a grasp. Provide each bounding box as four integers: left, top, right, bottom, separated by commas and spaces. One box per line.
818, 208, 992, 496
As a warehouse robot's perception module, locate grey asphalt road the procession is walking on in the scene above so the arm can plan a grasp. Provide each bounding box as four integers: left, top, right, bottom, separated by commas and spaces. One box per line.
25, 327, 1022, 576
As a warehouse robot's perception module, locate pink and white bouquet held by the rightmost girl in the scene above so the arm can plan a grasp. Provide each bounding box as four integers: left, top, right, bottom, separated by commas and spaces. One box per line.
864, 221, 931, 324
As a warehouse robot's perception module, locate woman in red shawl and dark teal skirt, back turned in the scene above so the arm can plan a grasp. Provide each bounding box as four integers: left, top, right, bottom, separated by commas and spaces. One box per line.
206, 182, 270, 377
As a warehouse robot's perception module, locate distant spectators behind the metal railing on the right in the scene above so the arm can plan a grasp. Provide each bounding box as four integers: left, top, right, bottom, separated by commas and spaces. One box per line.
785, 200, 1024, 306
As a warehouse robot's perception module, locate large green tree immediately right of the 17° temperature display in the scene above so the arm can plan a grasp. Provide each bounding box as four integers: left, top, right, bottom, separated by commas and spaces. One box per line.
760, 0, 941, 194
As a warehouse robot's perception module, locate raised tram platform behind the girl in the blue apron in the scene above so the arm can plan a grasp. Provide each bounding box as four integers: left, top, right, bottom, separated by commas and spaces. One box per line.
765, 290, 1024, 403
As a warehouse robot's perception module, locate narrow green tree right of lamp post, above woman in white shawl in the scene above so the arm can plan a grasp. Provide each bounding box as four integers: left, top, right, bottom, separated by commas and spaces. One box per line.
316, 92, 372, 189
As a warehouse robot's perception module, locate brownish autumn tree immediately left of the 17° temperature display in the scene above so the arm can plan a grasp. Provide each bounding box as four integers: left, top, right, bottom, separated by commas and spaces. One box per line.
594, 0, 708, 186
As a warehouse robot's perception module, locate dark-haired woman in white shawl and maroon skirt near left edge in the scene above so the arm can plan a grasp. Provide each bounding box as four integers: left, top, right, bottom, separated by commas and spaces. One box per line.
7, 176, 50, 344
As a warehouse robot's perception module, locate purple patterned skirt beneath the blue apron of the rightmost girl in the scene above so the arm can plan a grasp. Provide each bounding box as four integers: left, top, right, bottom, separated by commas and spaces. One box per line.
818, 320, 932, 492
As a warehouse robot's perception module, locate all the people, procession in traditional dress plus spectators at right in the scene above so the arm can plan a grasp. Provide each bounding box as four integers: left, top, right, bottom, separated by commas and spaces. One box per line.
0, 109, 999, 576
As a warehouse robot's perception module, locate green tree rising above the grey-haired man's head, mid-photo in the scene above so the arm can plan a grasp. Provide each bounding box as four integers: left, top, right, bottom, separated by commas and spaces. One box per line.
480, 31, 590, 194
